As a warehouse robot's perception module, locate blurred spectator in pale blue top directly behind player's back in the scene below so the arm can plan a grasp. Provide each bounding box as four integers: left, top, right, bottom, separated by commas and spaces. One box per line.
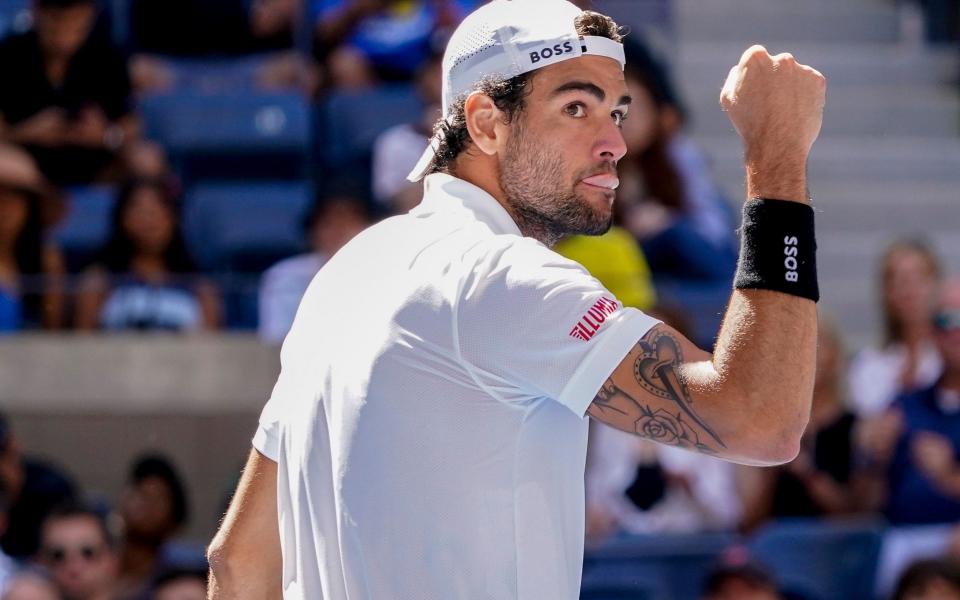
258, 197, 370, 344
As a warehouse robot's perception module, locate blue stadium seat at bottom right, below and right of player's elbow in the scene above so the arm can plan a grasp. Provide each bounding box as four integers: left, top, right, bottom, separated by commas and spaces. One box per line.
748, 519, 883, 600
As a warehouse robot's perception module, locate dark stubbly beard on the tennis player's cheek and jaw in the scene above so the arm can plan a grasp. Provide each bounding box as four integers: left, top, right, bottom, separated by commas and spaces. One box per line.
500, 119, 613, 246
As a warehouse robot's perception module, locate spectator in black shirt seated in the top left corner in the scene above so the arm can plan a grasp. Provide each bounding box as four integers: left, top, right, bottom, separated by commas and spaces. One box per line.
0, 0, 166, 185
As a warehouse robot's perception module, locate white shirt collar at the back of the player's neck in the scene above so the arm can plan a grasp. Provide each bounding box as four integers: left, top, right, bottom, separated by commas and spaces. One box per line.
412, 173, 523, 236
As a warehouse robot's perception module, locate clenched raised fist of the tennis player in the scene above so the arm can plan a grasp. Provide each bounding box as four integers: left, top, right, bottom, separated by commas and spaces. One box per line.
720, 46, 826, 186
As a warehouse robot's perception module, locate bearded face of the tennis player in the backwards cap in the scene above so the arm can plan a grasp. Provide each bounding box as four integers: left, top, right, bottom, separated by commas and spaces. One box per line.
499, 56, 630, 245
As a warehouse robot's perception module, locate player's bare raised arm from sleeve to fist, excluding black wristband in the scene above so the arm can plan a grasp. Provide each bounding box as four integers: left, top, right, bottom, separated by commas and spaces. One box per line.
587, 46, 826, 465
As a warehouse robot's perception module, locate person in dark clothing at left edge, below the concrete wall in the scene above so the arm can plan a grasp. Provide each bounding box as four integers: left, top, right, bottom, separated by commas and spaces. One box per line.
0, 414, 77, 560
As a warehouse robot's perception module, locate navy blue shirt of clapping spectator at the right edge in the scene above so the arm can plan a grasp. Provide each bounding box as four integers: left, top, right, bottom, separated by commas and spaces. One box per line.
887, 385, 960, 525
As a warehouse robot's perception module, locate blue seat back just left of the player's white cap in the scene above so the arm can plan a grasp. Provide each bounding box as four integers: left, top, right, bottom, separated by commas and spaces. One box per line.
318, 85, 423, 169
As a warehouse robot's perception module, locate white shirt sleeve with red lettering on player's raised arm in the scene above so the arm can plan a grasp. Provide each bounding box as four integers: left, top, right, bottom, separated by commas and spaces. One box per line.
454, 236, 658, 417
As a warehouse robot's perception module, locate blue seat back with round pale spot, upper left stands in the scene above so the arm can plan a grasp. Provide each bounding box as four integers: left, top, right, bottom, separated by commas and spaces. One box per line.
140, 91, 311, 181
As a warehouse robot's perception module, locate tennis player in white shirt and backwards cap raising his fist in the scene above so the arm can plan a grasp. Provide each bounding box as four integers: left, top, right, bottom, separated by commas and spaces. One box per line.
209, 0, 825, 600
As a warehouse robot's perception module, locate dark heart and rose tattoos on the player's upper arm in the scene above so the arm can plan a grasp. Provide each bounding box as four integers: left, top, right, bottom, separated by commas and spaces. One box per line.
587, 330, 726, 454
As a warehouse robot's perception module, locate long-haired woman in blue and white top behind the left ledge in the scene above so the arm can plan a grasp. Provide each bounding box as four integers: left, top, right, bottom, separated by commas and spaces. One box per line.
75, 180, 221, 331
